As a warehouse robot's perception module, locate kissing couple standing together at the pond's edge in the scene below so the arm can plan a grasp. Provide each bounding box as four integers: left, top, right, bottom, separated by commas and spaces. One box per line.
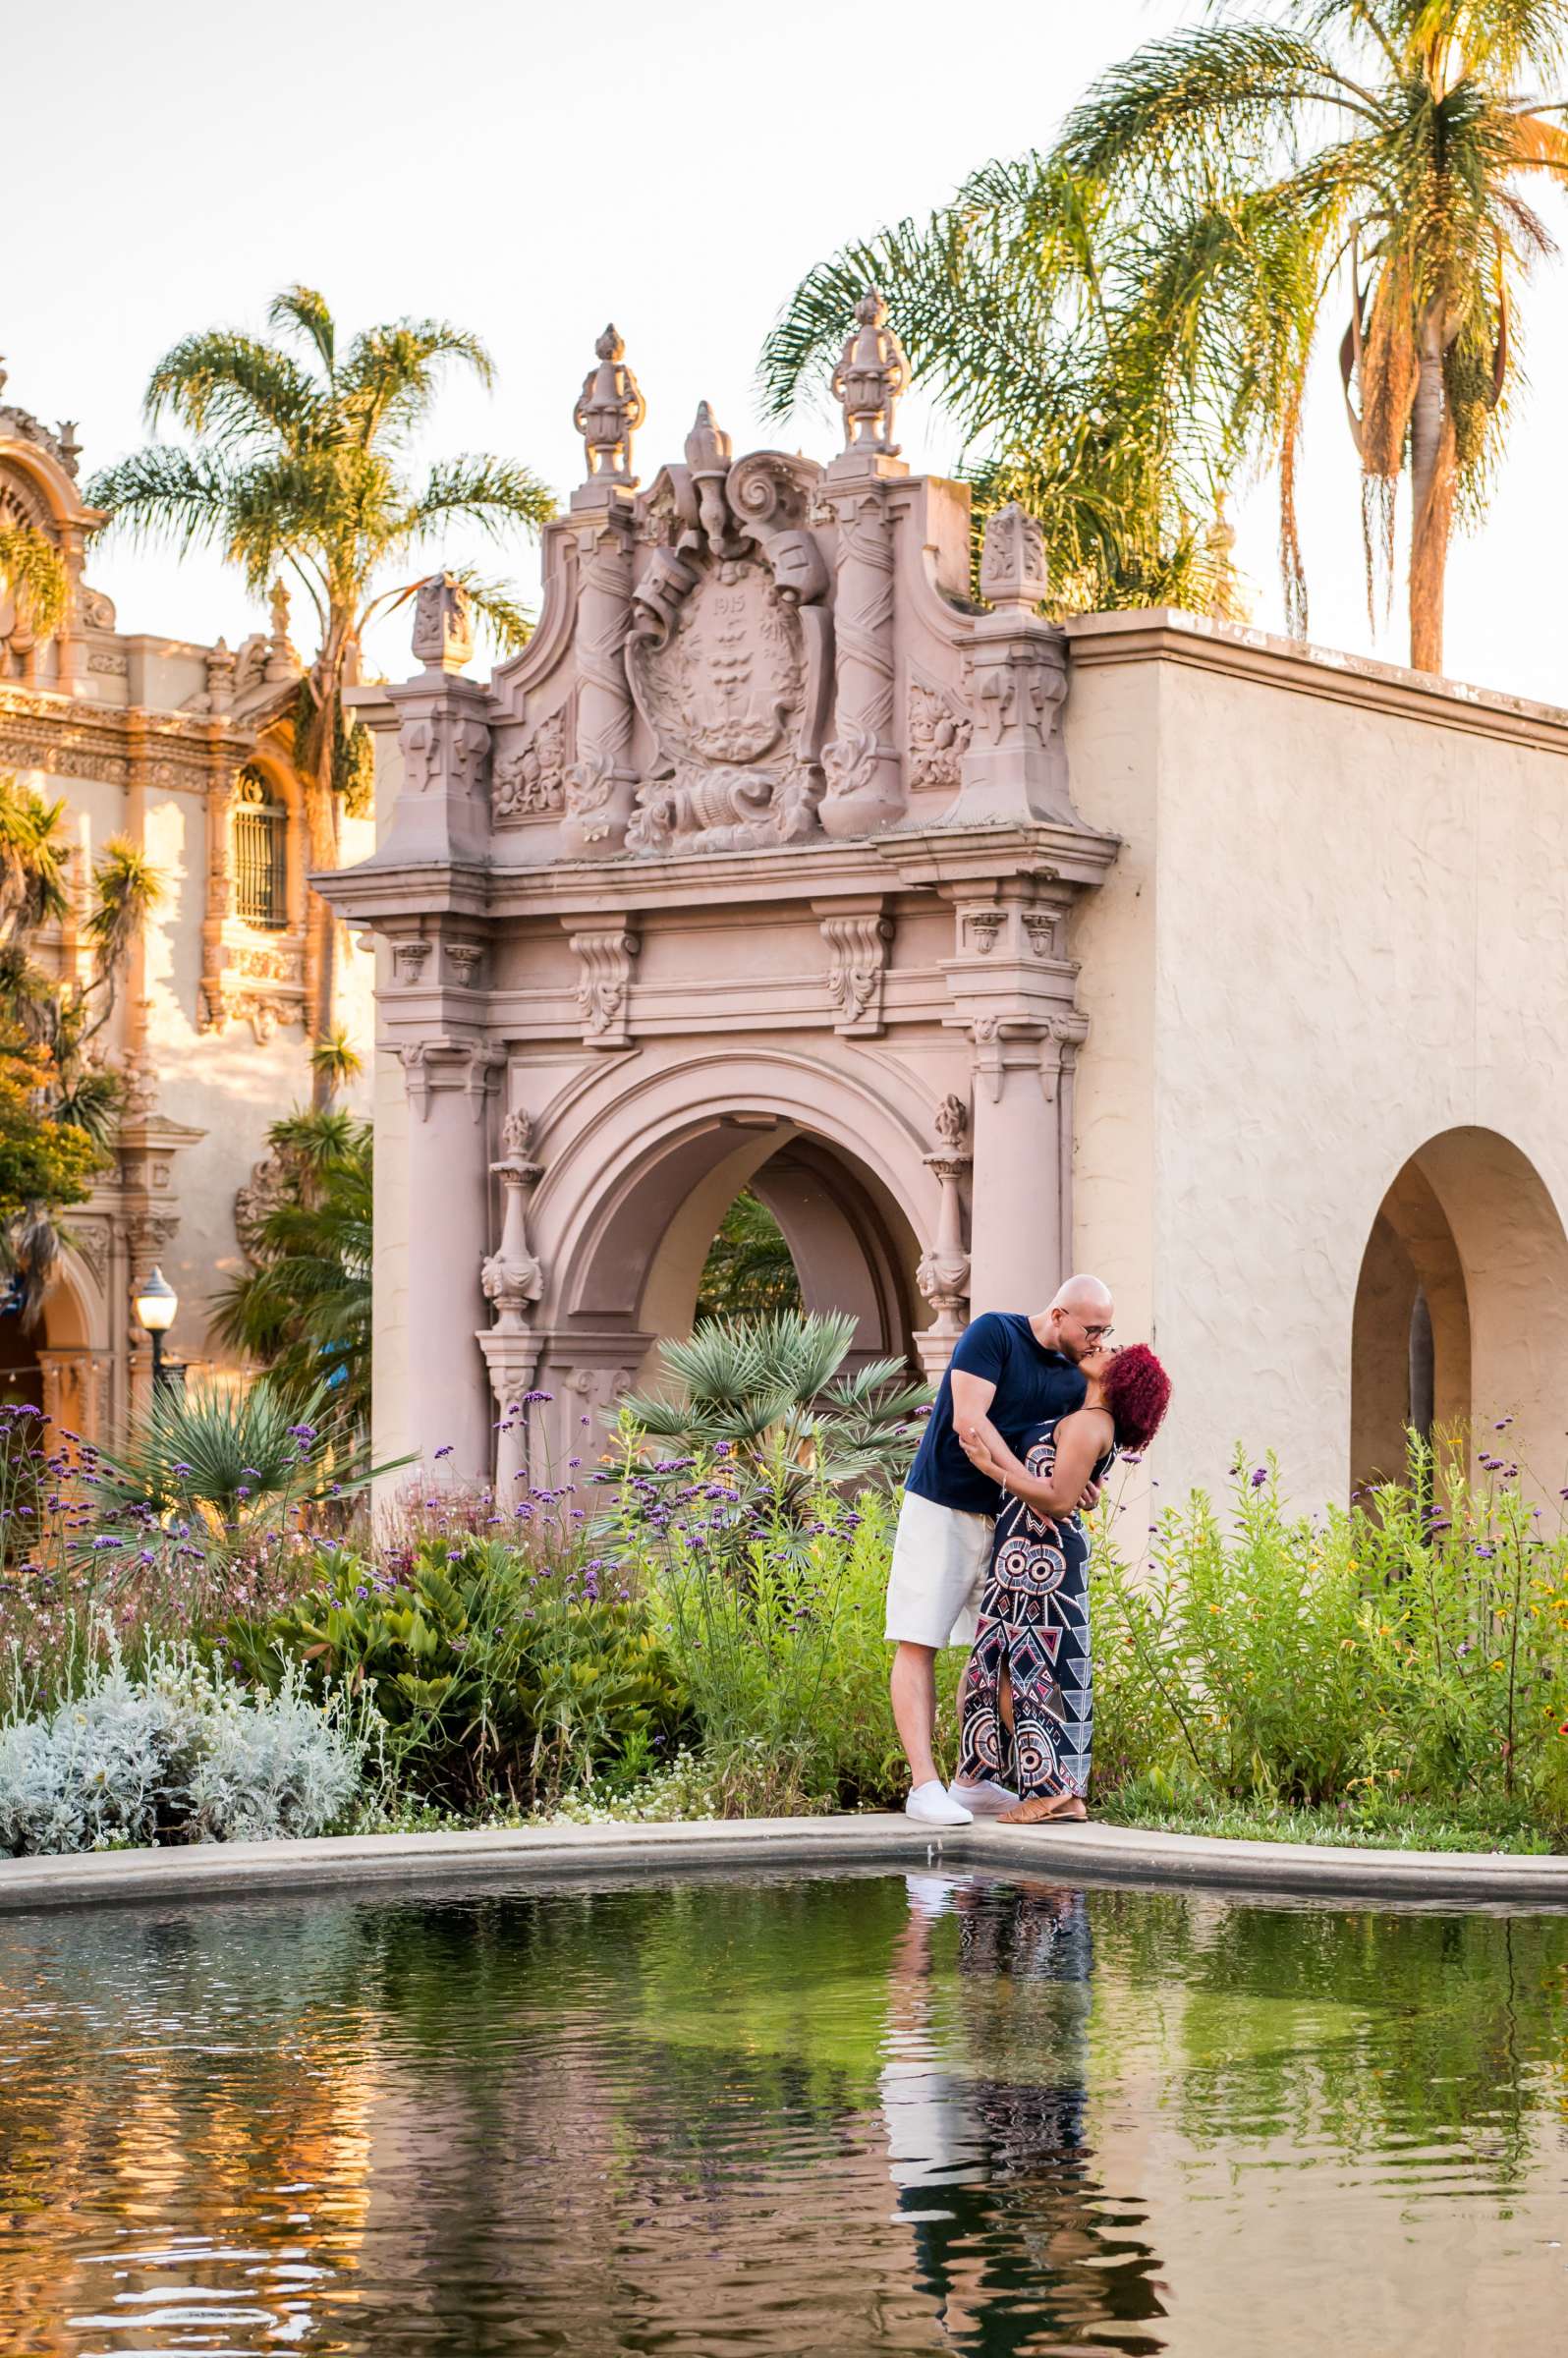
886, 1278, 1169, 1825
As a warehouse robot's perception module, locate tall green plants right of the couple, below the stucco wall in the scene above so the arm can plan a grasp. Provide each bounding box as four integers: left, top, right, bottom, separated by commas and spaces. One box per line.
1092, 1448, 1568, 1834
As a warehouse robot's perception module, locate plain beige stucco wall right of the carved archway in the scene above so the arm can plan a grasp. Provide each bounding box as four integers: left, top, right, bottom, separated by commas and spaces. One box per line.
1068, 615, 1568, 1502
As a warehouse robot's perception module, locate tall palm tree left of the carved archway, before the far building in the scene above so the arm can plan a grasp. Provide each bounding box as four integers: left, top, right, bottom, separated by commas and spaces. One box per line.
89, 285, 554, 1101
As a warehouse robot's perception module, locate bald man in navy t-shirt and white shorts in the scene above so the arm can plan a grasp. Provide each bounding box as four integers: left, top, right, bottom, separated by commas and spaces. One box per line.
886, 1278, 1115, 1825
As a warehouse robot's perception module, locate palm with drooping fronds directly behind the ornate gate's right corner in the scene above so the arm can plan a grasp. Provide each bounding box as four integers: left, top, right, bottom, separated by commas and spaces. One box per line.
759, 155, 1236, 613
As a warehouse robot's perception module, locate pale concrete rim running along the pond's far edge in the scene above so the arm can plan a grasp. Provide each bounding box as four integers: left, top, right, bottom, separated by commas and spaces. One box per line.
0, 1816, 1568, 1912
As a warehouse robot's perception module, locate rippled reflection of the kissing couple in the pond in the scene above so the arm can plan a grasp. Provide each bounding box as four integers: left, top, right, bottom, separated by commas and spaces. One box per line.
882, 1877, 1165, 2358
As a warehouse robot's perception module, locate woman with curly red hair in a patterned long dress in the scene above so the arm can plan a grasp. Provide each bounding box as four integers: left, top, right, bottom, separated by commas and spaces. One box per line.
955, 1342, 1169, 1825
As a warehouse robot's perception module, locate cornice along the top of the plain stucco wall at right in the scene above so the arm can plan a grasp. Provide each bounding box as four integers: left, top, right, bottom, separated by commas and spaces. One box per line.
1063, 606, 1568, 755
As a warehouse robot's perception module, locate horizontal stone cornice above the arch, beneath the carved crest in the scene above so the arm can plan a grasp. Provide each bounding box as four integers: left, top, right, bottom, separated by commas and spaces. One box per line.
311, 825, 1118, 925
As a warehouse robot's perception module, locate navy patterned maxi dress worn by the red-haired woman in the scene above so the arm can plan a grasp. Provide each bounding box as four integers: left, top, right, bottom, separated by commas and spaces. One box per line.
957, 1417, 1115, 1802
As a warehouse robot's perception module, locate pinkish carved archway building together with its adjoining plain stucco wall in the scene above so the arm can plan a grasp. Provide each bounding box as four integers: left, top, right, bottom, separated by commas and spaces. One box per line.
323, 309, 1568, 1497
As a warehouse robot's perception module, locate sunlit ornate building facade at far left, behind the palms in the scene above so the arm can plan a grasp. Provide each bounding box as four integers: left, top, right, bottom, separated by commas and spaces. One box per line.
0, 358, 372, 1438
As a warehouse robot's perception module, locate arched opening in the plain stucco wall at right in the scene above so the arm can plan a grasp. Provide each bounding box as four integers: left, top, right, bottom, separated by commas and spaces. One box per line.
1351, 1127, 1568, 1490
